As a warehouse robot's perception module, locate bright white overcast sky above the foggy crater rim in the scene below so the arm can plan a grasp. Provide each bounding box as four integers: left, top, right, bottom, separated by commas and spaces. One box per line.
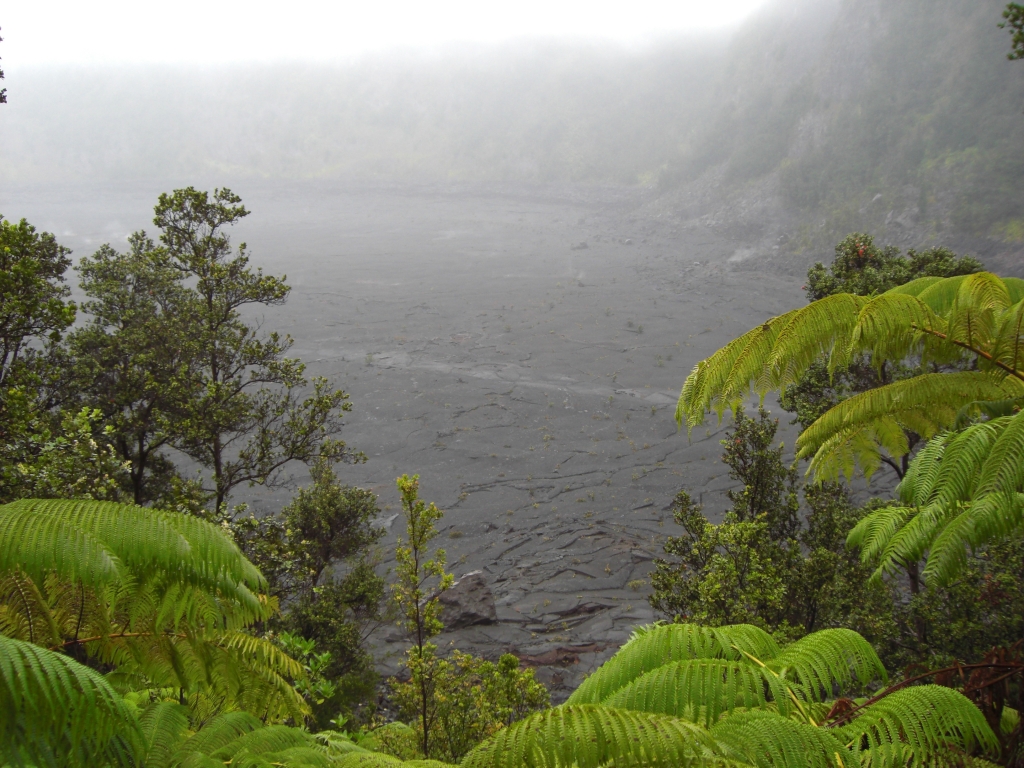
0, 0, 765, 67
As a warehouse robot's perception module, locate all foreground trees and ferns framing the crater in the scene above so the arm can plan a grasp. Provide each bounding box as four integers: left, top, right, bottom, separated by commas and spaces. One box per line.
8, 196, 1024, 766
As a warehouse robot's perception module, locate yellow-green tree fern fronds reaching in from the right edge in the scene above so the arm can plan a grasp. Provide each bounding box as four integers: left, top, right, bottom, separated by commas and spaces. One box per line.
676, 272, 1024, 580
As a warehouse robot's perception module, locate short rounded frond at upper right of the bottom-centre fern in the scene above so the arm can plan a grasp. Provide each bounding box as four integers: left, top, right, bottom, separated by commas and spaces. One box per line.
765, 629, 889, 701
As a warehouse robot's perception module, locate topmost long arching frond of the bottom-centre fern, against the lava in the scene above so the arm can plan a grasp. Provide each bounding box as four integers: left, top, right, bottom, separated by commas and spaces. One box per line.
566, 624, 779, 705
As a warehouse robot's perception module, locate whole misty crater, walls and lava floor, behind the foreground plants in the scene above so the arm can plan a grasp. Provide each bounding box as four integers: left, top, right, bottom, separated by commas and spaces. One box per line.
0, 0, 1024, 693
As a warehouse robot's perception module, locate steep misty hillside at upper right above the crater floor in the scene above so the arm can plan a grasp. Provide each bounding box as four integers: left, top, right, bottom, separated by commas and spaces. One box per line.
664, 0, 1024, 271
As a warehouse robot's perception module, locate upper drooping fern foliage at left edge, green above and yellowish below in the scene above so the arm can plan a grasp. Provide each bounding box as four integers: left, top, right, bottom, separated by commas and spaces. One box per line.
0, 500, 308, 720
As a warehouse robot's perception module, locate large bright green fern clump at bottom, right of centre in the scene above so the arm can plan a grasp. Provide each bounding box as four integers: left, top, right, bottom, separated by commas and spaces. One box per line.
313, 625, 998, 768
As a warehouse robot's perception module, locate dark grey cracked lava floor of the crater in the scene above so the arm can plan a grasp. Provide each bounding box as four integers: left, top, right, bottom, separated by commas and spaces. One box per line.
0, 183, 805, 698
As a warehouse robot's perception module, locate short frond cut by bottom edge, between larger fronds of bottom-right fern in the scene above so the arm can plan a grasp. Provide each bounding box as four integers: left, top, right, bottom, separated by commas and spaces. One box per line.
711, 712, 850, 768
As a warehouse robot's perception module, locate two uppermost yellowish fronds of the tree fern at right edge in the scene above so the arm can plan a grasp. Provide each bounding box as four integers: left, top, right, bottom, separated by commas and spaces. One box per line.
676, 272, 1024, 479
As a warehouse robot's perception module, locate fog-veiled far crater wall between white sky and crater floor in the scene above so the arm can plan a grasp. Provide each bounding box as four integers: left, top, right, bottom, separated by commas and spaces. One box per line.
0, 0, 836, 184
